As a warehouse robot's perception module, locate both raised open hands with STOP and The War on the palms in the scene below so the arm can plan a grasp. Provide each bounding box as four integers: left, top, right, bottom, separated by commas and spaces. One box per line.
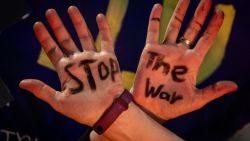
20, 0, 237, 140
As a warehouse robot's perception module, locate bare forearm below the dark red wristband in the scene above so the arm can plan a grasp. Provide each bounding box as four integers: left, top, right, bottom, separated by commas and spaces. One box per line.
90, 103, 182, 141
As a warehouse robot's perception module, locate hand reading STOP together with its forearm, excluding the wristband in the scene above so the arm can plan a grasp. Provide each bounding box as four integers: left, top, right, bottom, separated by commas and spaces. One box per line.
20, 6, 183, 141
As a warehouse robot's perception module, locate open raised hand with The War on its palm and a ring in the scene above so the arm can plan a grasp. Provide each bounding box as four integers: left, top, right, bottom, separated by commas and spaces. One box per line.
131, 0, 237, 121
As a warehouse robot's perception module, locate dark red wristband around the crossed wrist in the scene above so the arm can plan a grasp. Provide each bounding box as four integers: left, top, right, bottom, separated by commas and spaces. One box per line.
93, 90, 133, 135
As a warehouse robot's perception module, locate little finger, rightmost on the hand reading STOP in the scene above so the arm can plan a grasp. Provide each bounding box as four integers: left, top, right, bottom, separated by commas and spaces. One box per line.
96, 14, 114, 53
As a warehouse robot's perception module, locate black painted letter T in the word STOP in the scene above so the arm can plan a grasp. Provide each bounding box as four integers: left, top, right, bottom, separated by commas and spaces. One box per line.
79, 59, 96, 90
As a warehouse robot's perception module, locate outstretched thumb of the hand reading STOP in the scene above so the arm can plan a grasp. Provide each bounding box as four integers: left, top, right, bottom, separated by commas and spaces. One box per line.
19, 79, 60, 110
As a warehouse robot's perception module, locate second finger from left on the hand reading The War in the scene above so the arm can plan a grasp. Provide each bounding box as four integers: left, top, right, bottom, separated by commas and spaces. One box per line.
164, 0, 190, 44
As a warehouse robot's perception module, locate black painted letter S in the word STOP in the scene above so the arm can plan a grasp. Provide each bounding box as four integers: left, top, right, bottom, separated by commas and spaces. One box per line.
63, 64, 84, 94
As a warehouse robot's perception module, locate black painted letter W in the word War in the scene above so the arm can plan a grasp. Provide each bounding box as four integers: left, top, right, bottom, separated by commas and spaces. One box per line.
145, 78, 164, 98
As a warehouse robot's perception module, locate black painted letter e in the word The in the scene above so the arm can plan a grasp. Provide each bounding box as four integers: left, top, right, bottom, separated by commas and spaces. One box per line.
171, 66, 188, 82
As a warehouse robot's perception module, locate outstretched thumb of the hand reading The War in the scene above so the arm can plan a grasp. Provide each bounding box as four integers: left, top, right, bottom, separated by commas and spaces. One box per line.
196, 81, 238, 105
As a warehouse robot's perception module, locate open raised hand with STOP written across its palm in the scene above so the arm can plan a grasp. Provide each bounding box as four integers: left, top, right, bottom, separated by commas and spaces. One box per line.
20, 6, 124, 126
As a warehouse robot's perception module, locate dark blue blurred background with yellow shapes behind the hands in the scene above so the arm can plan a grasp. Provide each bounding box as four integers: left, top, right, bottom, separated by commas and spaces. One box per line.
0, 0, 250, 141
